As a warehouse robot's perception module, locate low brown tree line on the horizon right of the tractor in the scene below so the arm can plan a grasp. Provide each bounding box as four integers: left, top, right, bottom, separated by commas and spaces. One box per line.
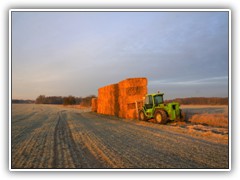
165, 97, 228, 105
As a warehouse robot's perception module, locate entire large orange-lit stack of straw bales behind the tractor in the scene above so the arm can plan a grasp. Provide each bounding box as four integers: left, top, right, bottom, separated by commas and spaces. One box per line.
92, 78, 147, 119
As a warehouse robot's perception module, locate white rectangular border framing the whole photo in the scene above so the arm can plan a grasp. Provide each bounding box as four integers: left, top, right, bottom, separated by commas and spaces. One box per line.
8, 9, 232, 172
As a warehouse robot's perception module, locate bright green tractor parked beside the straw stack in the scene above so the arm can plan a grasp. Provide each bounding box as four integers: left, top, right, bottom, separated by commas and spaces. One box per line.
138, 93, 185, 124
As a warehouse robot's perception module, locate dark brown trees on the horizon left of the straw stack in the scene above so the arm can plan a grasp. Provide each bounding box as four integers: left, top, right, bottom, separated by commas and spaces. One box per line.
35, 95, 96, 106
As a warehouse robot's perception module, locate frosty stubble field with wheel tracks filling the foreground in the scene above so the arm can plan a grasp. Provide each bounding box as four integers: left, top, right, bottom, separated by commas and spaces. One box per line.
11, 105, 228, 169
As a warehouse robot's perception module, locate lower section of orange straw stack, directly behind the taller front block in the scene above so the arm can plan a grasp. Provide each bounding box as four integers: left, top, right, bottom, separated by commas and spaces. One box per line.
97, 84, 119, 115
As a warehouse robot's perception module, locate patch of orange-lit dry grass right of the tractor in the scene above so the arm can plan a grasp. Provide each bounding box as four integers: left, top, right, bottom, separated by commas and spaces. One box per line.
190, 113, 228, 127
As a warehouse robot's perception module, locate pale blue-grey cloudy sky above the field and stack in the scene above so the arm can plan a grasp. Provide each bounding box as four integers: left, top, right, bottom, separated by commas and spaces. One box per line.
11, 11, 229, 99
